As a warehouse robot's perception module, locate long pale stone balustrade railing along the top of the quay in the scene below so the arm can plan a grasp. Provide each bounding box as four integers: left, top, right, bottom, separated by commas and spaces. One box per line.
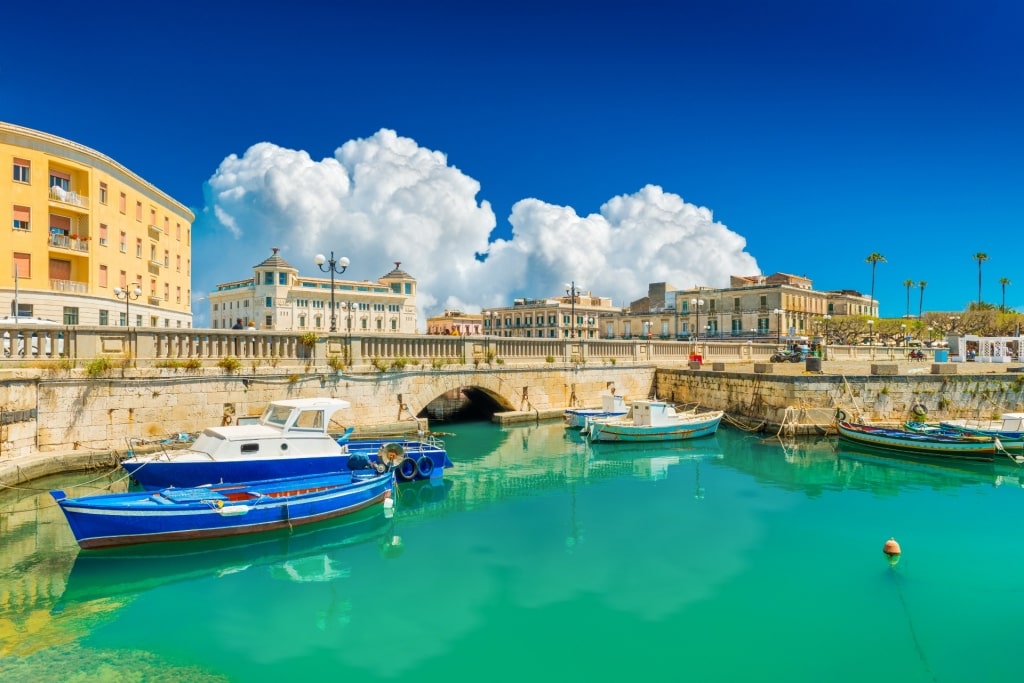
0, 325, 932, 368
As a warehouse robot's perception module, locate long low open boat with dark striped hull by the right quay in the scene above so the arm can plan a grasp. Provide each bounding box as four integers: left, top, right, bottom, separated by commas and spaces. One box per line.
836, 420, 1016, 462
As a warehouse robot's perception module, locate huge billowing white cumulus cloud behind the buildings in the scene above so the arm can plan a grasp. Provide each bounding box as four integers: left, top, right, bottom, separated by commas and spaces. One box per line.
194, 129, 759, 329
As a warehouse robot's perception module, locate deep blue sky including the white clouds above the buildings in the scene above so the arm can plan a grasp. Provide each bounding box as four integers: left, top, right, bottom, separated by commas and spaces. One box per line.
0, 0, 1024, 323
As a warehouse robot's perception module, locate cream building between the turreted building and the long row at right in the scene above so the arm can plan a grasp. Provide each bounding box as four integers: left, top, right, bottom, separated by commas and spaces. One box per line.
481, 291, 621, 339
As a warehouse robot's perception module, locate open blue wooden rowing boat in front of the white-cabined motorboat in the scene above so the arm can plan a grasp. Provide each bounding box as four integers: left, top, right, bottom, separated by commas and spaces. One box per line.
50, 470, 394, 549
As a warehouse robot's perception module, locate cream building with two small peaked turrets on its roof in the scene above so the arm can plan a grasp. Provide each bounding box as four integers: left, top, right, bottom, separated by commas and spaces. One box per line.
207, 249, 417, 334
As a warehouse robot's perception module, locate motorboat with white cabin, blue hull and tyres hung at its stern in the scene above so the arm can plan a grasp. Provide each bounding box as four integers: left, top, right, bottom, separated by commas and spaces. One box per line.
121, 398, 452, 490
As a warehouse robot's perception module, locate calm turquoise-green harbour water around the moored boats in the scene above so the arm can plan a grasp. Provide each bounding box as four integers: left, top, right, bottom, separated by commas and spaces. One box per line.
0, 422, 1024, 682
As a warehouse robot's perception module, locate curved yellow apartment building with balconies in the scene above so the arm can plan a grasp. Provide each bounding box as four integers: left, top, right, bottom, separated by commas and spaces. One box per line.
0, 122, 195, 328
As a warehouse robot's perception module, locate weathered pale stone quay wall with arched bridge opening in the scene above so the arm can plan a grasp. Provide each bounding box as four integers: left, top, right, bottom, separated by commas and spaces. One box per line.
0, 337, 1024, 485
